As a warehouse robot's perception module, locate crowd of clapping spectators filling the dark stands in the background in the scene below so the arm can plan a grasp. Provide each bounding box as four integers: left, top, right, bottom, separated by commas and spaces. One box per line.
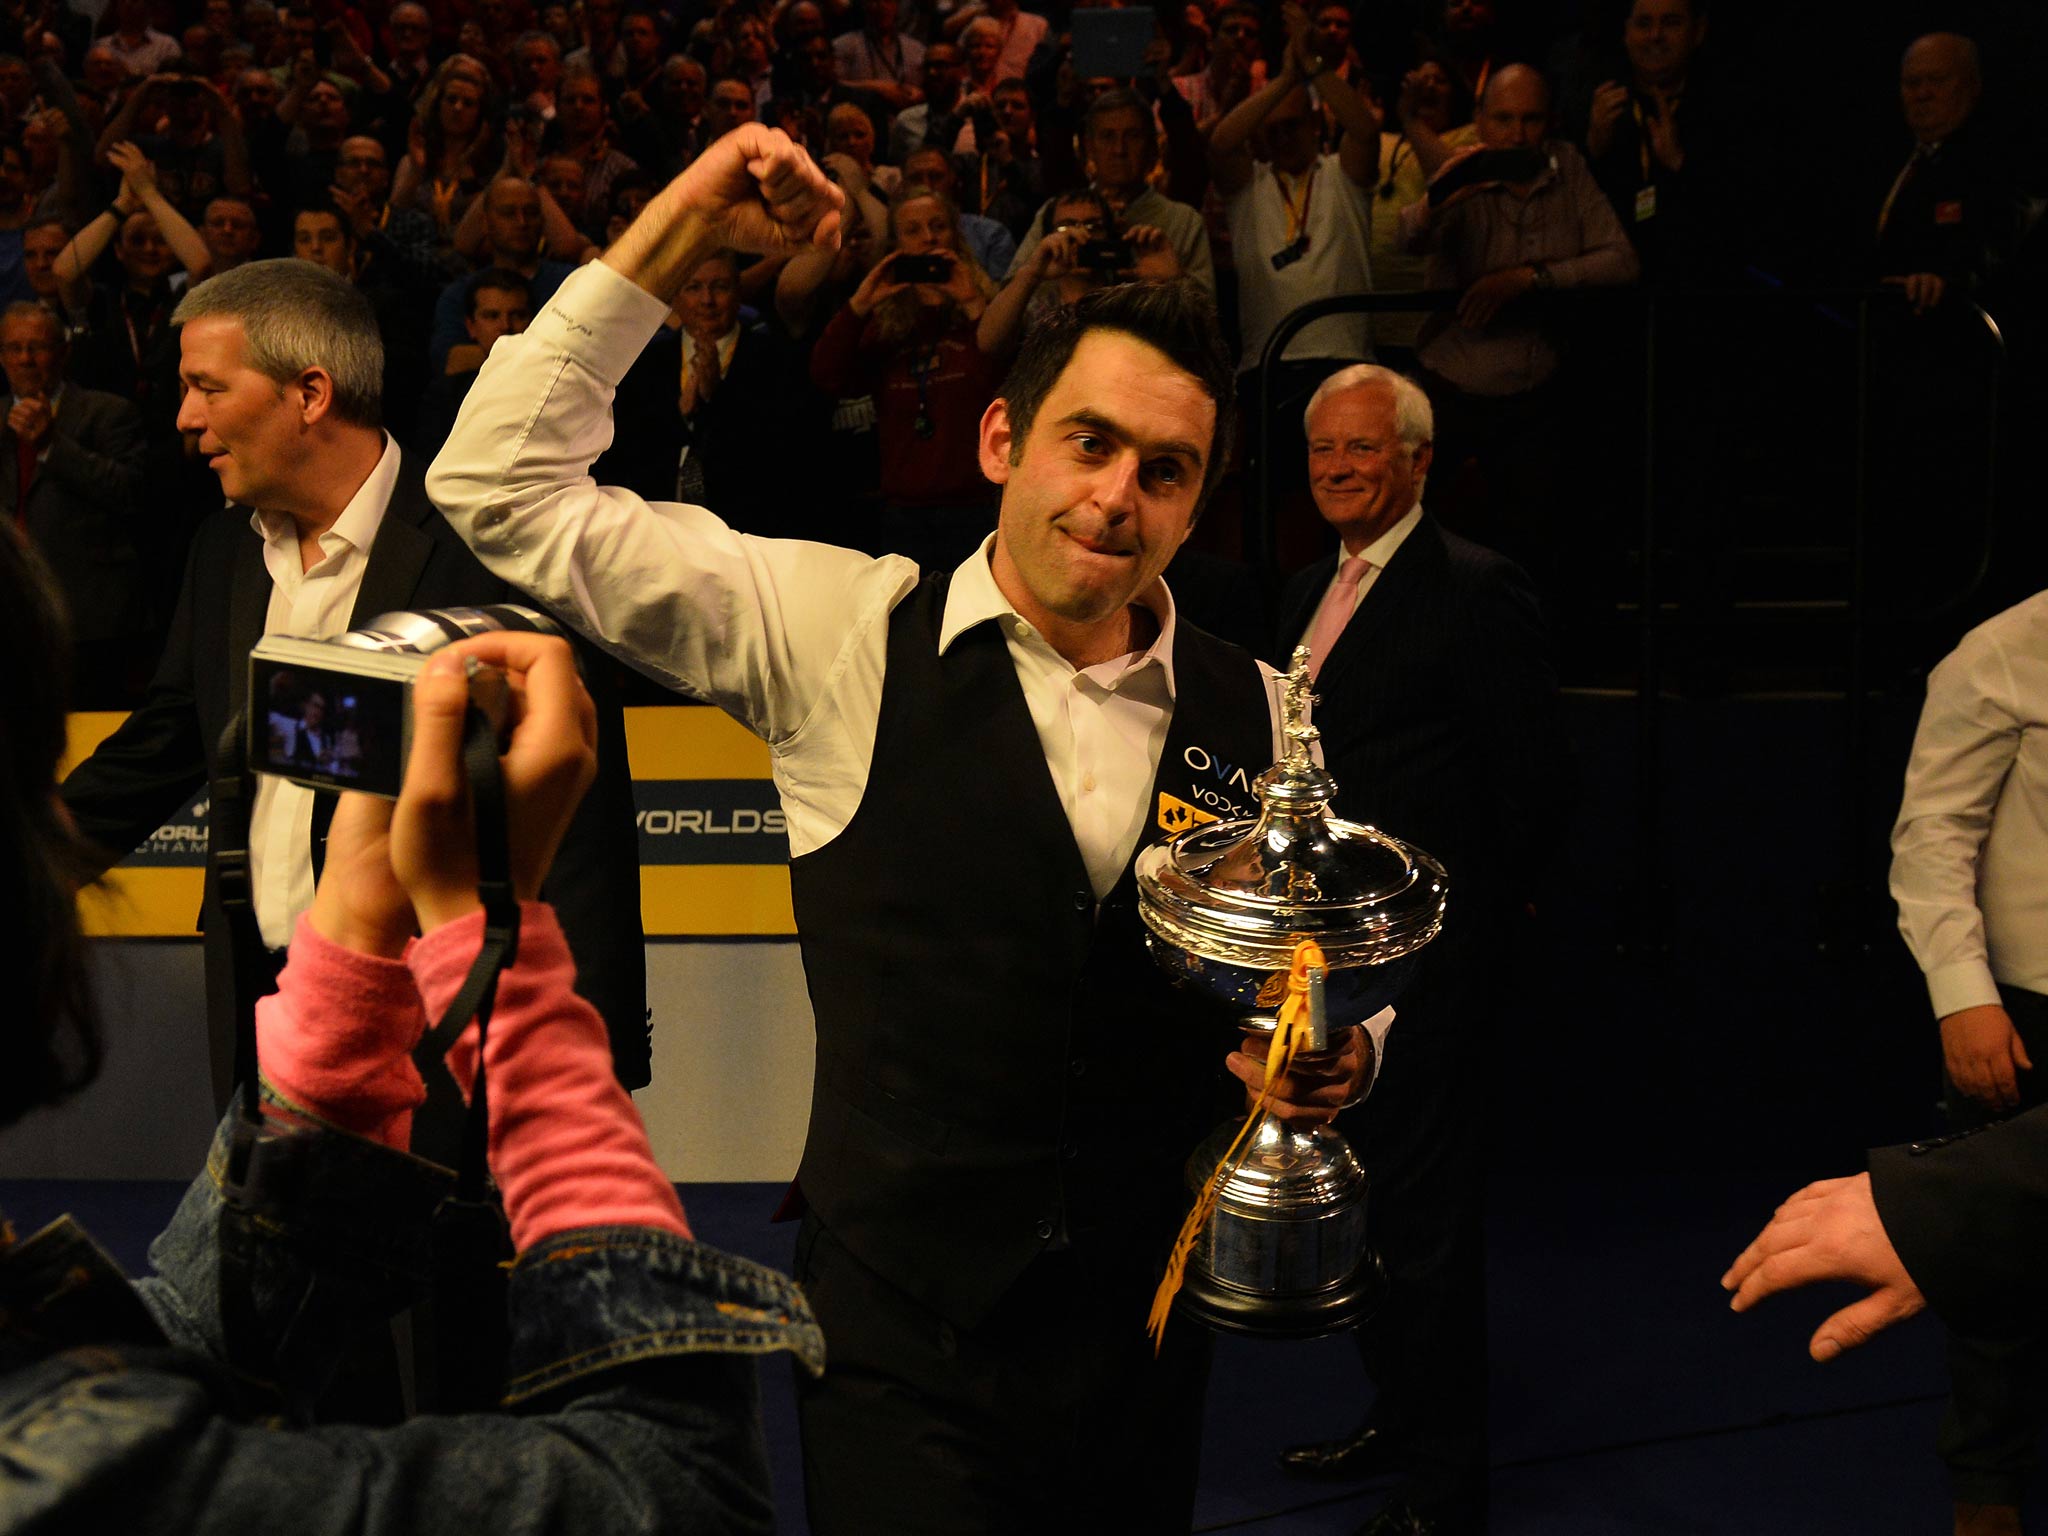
0, 0, 2030, 705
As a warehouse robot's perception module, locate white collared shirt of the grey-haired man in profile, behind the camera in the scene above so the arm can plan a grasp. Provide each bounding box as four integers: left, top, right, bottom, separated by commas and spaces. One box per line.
250, 436, 399, 948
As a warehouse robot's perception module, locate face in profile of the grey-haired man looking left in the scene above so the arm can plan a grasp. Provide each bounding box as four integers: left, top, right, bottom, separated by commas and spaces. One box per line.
178, 315, 305, 506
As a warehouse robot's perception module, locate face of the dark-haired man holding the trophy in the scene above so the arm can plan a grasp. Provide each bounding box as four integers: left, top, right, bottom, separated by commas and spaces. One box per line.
981, 330, 1217, 629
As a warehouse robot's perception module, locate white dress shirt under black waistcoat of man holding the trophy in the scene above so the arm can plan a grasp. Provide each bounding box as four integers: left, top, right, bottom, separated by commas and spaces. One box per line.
428, 262, 1393, 1073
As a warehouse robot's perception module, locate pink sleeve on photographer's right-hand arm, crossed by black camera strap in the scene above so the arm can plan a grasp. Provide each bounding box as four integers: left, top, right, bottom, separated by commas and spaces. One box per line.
406, 901, 690, 1251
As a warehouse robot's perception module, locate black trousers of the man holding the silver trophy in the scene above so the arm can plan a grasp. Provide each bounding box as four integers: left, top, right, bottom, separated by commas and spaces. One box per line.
795, 1214, 1210, 1536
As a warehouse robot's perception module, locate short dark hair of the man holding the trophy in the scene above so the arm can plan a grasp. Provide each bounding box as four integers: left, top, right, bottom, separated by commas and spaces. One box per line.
1001, 279, 1237, 518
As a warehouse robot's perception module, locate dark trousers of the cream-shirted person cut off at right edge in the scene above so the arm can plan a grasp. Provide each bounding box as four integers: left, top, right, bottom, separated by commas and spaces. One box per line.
1935, 985, 2048, 1503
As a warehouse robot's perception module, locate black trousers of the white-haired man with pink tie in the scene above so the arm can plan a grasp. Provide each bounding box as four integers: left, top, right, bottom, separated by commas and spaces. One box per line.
1337, 913, 1501, 1520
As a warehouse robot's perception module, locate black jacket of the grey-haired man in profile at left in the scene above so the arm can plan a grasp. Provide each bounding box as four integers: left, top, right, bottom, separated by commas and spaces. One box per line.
61, 455, 647, 1100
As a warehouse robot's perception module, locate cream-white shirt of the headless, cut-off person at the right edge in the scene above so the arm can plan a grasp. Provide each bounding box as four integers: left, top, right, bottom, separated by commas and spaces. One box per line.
1892, 592, 2048, 1018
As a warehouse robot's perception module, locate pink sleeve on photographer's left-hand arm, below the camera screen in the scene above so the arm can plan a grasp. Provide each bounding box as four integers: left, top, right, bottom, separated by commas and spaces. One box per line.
256, 918, 426, 1151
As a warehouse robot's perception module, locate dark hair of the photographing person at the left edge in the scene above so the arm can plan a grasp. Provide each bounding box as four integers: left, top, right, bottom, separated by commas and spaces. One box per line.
0, 539, 100, 1126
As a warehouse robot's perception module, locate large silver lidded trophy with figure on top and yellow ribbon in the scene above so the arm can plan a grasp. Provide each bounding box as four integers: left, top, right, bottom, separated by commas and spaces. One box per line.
1137, 649, 1448, 1337
